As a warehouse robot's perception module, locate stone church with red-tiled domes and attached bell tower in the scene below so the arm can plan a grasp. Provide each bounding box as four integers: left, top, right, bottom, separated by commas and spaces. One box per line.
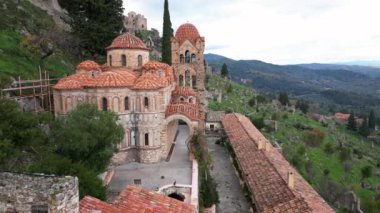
54, 23, 205, 163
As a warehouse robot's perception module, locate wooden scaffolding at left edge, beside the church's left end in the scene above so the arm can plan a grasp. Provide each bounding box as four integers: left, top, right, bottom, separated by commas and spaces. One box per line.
1, 68, 59, 113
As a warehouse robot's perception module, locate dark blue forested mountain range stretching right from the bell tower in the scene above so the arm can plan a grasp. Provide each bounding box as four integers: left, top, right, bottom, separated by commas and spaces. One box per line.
205, 54, 380, 110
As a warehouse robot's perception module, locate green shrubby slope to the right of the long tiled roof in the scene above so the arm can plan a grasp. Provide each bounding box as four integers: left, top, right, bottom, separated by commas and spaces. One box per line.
207, 75, 380, 212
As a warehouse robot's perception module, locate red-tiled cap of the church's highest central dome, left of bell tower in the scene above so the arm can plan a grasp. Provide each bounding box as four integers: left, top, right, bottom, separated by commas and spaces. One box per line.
106, 33, 148, 50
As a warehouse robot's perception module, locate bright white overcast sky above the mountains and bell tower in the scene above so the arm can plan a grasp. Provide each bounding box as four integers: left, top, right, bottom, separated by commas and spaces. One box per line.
124, 0, 380, 64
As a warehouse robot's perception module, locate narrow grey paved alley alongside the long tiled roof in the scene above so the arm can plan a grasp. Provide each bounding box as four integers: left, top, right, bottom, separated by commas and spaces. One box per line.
207, 137, 250, 213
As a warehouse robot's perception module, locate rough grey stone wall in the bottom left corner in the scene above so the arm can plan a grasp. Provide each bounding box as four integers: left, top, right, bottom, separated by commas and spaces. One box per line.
0, 173, 79, 213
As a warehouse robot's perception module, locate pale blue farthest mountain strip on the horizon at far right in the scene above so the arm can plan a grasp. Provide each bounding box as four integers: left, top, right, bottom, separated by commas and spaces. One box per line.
297, 63, 380, 77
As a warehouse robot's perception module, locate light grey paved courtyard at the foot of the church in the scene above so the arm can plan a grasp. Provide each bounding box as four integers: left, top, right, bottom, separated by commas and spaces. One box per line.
108, 125, 192, 201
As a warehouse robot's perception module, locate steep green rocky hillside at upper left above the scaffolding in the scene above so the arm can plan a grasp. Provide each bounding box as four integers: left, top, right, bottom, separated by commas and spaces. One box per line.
0, 0, 77, 86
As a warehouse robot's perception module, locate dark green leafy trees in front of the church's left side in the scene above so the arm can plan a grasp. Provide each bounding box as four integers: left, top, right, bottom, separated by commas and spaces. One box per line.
0, 99, 123, 200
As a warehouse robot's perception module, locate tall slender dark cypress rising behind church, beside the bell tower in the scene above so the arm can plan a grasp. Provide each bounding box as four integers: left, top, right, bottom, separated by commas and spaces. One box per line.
162, 0, 173, 65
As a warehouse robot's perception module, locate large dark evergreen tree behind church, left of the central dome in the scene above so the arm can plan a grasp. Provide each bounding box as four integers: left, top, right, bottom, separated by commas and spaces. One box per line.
59, 0, 124, 57
